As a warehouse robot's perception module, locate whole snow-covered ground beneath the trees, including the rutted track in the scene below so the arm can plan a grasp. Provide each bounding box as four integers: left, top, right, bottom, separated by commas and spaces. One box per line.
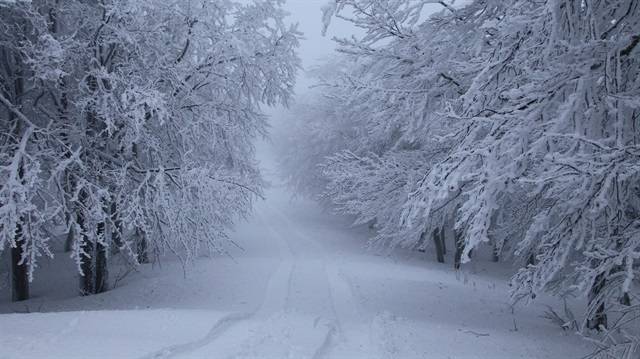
0, 145, 589, 359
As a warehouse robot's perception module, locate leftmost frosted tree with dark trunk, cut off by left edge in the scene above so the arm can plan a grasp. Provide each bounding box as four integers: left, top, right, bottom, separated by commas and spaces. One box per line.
0, 1, 64, 300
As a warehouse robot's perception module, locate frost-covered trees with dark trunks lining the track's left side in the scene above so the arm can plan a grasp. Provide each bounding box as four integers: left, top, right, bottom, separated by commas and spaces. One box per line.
0, 0, 300, 300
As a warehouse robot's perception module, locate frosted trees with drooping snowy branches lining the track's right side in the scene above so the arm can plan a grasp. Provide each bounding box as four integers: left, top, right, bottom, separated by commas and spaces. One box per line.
282, 0, 640, 358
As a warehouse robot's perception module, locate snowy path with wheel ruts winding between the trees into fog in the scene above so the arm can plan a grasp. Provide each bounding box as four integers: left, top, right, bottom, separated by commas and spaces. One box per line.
147, 200, 377, 358
